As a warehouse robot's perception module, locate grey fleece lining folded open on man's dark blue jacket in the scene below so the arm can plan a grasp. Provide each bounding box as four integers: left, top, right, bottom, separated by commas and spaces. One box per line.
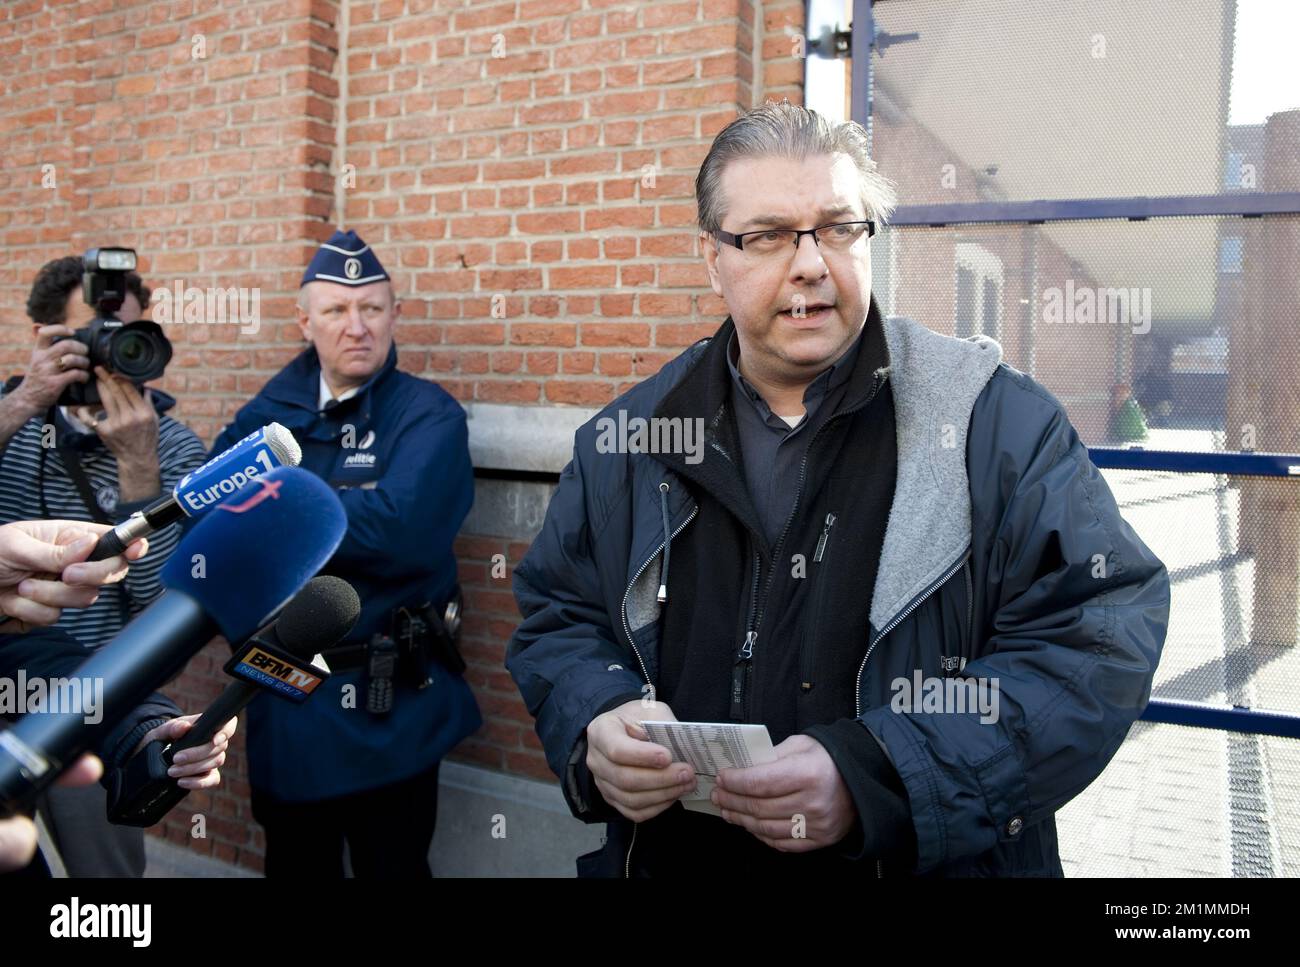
871, 317, 1002, 630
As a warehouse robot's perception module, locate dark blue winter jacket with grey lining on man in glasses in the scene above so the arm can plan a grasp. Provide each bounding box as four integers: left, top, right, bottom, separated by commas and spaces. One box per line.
507, 303, 1169, 876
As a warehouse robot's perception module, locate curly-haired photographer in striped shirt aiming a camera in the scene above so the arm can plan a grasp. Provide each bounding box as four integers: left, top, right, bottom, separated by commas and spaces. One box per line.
0, 256, 204, 876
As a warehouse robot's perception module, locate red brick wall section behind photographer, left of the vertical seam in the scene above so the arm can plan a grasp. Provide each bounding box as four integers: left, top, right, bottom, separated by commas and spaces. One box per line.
0, 0, 337, 439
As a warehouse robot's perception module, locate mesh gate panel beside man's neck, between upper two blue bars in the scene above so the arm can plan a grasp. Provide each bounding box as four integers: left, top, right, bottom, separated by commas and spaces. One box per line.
871, 214, 1300, 452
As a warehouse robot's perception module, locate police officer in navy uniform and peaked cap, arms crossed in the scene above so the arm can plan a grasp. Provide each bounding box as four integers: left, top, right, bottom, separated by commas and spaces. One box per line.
212, 231, 482, 877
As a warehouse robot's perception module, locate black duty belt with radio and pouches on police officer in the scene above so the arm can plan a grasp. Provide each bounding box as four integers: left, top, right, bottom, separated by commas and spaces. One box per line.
321, 584, 465, 715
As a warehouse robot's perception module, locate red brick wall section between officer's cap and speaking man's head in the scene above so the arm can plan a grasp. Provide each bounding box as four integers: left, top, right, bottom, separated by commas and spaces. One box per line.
332, 0, 754, 406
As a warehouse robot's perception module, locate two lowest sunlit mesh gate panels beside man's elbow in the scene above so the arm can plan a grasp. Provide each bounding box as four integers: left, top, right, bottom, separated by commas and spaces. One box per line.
1058, 471, 1300, 876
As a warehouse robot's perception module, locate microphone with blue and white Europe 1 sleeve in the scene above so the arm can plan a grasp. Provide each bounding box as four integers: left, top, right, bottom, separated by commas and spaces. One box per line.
87, 424, 303, 560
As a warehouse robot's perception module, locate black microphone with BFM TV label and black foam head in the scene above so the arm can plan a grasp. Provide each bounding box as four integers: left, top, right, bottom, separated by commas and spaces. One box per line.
108, 576, 361, 827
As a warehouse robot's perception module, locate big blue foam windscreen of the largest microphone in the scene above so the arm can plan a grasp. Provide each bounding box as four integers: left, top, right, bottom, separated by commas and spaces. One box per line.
163, 467, 347, 643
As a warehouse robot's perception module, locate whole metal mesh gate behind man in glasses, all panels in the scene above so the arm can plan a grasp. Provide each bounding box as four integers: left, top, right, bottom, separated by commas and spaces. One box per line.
845, 0, 1300, 876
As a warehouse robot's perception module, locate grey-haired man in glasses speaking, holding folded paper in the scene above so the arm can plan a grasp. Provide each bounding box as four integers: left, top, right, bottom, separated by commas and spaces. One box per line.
507, 104, 1169, 879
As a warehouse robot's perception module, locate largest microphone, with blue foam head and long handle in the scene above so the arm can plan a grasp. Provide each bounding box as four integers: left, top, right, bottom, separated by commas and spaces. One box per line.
0, 467, 347, 814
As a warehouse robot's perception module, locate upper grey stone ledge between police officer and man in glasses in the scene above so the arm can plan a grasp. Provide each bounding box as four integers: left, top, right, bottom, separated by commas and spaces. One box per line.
463, 402, 601, 473
